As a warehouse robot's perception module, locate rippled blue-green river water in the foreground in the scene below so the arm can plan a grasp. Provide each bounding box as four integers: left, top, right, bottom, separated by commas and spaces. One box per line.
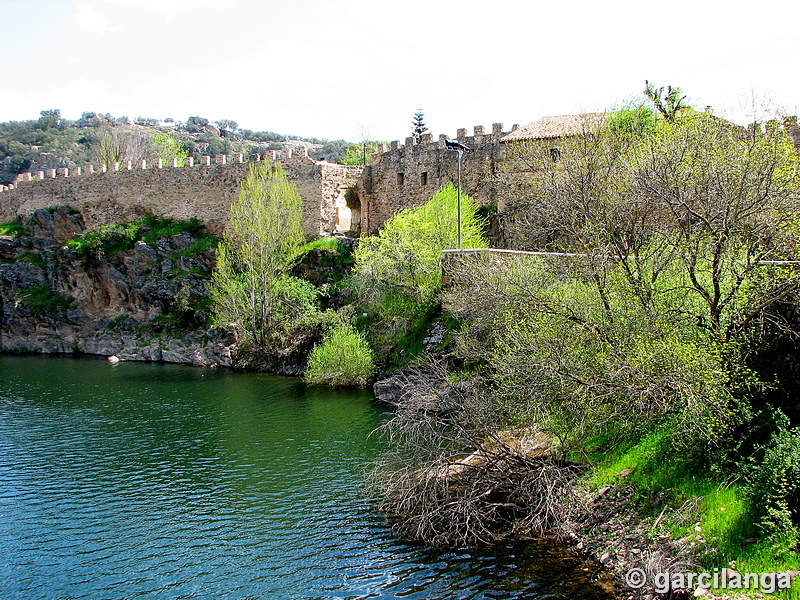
0, 356, 606, 600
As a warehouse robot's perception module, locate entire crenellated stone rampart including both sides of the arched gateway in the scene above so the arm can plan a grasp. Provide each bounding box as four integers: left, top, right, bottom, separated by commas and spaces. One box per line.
0, 123, 516, 237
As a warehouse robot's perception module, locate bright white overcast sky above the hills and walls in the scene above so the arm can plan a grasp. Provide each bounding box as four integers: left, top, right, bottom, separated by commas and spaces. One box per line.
0, 0, 800, 141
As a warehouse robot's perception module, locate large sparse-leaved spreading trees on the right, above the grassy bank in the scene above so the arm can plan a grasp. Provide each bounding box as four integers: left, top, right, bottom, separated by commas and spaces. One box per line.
472, 96, 800, 445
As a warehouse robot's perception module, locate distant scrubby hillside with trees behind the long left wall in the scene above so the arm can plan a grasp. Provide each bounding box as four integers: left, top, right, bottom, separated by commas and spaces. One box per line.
0, 110, 361, 184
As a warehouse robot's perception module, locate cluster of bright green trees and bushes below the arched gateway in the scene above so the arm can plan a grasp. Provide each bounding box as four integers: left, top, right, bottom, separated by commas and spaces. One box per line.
212, 171, 486, 386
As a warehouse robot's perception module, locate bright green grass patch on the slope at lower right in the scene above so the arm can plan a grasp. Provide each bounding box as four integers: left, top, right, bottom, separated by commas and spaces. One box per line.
585, 426, 800, 599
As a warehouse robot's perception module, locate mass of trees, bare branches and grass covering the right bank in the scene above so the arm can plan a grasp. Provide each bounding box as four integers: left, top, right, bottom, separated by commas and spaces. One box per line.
362, 97, 800, 596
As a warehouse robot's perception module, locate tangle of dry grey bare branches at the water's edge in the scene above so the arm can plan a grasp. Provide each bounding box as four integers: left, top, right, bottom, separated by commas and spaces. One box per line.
370, 362, 580, 545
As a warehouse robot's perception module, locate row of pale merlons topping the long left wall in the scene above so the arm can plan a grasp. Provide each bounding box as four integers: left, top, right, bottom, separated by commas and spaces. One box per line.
0, 147, 317, 192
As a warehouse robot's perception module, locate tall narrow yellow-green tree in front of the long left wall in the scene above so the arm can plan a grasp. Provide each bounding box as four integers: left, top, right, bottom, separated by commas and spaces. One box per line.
211, 161, 316, 360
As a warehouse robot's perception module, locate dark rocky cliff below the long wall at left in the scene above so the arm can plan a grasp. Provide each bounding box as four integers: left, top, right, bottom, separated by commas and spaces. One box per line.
0, 207, 234, 366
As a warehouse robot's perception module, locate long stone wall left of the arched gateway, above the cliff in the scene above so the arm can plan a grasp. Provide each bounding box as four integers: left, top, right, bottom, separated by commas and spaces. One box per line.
0, 149, 366, 237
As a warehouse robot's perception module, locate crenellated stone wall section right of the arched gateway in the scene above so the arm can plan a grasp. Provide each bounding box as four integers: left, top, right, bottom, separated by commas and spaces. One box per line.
364, 123, 517, 233
